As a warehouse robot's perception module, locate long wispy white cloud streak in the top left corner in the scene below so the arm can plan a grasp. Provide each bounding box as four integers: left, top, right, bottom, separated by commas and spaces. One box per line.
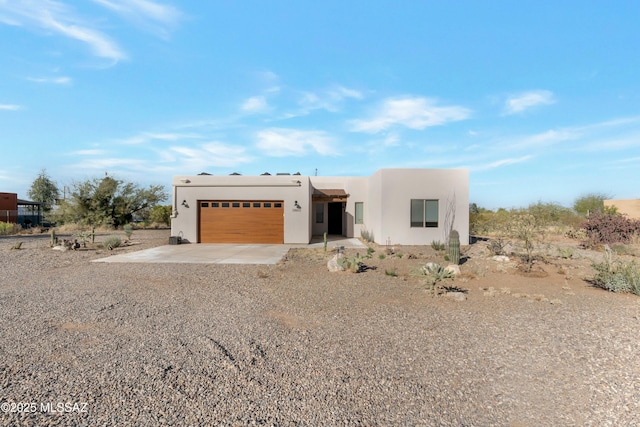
0, 0, 127, 63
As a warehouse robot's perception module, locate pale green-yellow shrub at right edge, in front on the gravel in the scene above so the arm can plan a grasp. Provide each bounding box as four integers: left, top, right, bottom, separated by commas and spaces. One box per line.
593, 248, 640, 295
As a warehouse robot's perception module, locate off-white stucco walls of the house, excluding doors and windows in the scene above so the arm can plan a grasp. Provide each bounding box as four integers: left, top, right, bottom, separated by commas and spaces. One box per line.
171, 169, 469, 245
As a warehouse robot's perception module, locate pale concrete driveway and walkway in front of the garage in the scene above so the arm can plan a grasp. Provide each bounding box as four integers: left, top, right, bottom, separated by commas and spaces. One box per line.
93, 238, 366, 264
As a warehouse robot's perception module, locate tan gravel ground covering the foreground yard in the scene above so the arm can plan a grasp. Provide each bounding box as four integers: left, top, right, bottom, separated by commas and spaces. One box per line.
0, 230, 640, 426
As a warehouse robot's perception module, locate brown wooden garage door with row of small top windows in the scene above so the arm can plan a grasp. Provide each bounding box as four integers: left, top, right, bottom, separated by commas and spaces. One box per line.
199, 200, 284, 243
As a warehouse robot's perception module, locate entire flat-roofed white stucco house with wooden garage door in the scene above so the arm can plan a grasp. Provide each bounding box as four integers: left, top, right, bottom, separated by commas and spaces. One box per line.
171, 169, 469, 245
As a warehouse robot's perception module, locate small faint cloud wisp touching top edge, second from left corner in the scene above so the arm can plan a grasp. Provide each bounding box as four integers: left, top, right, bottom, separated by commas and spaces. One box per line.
93, 0, 183, 37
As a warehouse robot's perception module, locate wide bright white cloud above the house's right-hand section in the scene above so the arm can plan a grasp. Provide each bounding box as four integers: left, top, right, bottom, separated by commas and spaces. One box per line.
351, 97, 471, 133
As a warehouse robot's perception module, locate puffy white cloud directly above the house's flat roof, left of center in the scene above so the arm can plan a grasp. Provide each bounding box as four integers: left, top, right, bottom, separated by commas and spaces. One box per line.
256, 128, 336, 157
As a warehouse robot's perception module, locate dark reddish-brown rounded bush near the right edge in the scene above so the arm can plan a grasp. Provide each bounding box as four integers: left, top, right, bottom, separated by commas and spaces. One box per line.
582, 212, 640, 246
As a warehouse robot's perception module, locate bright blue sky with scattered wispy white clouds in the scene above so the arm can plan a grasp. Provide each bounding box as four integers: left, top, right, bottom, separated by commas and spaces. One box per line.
0, 0, 640, 208
